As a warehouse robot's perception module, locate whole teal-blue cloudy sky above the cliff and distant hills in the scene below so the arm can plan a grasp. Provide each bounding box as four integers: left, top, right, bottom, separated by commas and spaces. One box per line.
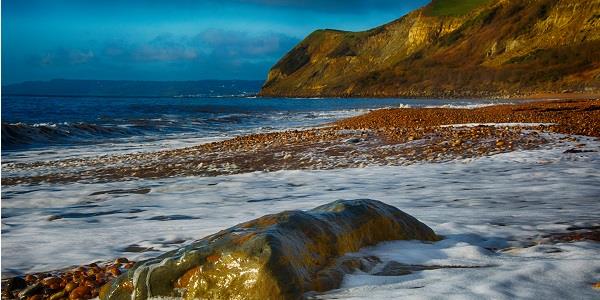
1, 0, 429, 85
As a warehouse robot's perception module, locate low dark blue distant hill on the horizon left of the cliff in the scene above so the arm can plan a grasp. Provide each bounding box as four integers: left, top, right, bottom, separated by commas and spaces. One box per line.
2, 79, 262, 97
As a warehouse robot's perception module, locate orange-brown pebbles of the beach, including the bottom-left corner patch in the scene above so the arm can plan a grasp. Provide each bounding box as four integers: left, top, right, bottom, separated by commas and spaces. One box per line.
2, 100, 600, 299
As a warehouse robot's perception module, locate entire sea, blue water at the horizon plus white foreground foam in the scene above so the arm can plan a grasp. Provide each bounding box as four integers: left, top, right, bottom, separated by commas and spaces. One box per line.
1, 95, 600, 299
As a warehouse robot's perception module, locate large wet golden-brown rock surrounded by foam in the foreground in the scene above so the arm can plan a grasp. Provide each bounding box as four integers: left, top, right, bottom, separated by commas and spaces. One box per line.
100, 200, 437, 299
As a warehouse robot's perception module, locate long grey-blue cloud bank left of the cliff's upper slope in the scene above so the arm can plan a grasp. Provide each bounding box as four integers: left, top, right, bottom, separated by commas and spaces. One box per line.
35, 29, 299, 66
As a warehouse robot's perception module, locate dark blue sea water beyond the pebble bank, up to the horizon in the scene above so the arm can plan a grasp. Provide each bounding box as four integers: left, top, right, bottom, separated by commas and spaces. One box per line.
2, 96, 502, 158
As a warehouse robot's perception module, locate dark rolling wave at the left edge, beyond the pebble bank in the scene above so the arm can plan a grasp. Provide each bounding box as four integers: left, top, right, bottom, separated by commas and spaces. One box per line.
2, 122, 133, 150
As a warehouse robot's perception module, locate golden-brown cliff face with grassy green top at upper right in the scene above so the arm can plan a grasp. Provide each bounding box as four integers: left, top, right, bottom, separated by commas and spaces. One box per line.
261, 0, 600, 97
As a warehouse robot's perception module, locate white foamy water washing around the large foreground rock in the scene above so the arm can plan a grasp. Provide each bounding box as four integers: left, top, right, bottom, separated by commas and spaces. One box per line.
2, 140, 600, 299
